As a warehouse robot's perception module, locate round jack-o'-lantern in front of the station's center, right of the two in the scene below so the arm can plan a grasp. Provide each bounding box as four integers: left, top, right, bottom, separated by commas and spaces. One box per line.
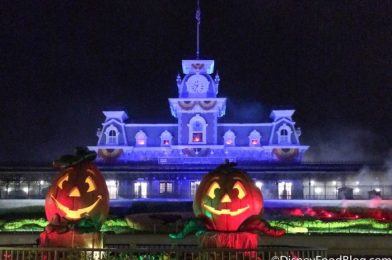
193, 168, 263, 231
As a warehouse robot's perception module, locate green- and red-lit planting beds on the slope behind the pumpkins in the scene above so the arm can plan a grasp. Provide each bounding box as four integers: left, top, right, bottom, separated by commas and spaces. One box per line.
0, 207, 392, 235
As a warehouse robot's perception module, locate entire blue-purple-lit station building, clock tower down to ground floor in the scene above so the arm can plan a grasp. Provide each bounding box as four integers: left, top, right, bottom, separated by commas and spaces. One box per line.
0, 59, 392, 202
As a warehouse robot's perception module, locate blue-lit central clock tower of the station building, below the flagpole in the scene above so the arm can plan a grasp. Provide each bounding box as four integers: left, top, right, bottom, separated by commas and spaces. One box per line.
169, 59, 226, 146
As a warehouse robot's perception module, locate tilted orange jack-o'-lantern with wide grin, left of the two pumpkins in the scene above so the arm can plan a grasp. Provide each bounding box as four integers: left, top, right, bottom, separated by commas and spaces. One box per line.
45, 162, 109, 223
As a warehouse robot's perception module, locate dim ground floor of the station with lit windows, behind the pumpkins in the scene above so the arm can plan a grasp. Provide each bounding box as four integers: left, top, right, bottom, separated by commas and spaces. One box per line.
0, 163, 392, 201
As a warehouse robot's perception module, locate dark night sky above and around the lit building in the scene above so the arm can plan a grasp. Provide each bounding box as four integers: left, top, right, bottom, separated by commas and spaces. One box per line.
0, 0, 392, 162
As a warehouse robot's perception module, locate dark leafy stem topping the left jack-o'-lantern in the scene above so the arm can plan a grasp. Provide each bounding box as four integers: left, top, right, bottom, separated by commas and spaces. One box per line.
53, 147, 97, 169
